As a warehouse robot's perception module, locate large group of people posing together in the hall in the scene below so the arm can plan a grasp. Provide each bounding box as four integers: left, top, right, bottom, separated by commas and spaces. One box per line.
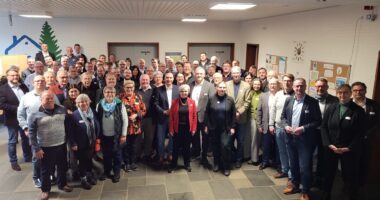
0, 44, 380, 200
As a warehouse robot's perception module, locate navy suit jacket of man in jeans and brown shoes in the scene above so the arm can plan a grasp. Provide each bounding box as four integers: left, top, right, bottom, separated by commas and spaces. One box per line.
281, 94, 322, 140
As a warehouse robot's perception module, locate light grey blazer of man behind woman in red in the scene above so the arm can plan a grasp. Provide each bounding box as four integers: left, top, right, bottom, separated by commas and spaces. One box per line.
190, 80, 215, 123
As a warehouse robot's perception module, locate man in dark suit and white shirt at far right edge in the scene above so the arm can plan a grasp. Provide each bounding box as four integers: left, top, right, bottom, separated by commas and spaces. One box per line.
352, 82, 380, 185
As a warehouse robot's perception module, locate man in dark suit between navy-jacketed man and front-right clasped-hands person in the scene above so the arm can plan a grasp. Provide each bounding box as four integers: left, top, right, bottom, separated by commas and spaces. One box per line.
311, 78, 339, 188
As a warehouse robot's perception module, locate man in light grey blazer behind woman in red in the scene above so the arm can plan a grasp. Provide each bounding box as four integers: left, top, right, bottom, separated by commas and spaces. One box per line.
190, 67, 215, 167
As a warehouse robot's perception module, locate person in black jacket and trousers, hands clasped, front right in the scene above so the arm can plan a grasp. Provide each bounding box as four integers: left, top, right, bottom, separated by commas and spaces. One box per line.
321, 84, 366, 200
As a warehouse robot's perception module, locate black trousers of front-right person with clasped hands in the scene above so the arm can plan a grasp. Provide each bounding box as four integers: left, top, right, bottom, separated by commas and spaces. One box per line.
322, 148, 359, 200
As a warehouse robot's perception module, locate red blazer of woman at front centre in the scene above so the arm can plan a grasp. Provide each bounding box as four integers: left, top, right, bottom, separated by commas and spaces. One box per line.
169, 97, 198, 135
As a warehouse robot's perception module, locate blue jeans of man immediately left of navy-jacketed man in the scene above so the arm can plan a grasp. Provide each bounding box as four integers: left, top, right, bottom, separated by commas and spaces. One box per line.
276, 127, 291, 178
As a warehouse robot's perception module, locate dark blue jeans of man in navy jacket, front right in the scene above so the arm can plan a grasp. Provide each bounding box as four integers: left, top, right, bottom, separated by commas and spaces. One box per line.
286, 133, 313, 193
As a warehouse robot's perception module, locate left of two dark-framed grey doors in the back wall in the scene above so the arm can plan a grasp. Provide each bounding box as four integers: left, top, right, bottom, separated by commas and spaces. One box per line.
108, 42, 159, 65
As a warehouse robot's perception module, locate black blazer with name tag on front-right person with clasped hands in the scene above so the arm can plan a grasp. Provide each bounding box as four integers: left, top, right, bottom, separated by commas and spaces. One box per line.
321, 101, 366, 151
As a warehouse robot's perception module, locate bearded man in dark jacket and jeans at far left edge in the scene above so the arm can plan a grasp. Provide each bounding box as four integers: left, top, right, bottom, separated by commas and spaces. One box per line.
0, 66, 32, 171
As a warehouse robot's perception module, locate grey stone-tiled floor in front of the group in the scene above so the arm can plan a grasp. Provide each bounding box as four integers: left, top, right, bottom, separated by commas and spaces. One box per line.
0, 127, 376, 200
